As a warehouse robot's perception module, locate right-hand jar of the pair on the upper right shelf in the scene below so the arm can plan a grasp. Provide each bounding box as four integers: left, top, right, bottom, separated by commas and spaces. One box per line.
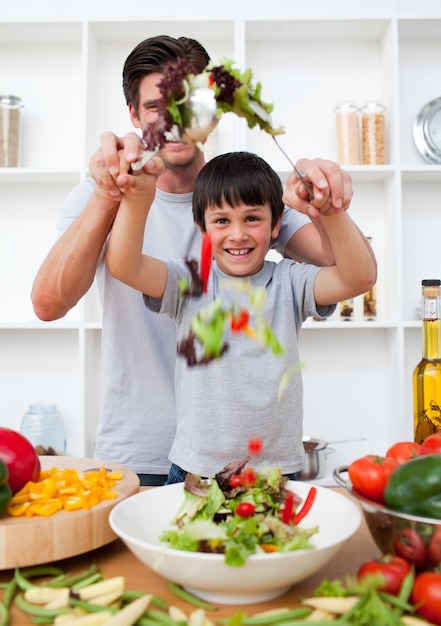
361, 102, 386, 165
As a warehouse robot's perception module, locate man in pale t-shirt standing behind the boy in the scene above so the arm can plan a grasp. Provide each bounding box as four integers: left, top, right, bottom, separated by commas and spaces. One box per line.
32, 35, 358, 485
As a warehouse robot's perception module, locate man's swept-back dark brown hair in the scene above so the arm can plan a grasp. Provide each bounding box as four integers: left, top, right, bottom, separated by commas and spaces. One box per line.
123, 35, 210, 113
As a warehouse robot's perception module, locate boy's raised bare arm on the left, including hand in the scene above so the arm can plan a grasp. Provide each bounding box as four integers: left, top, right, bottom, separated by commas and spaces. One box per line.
106, 159, 167, 298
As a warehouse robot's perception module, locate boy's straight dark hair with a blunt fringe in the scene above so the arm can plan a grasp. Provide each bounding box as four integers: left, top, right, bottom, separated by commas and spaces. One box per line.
193, 152, 284, 231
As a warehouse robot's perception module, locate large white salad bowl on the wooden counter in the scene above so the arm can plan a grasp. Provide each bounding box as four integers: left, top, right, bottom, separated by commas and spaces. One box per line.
109, 481, 361, 604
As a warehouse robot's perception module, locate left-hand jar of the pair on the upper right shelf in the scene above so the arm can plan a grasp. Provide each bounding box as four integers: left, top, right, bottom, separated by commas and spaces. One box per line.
334, 102, 360, 165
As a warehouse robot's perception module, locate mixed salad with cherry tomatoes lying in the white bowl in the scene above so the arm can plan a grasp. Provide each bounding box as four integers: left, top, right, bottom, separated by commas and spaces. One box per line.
160, 457, 318, 567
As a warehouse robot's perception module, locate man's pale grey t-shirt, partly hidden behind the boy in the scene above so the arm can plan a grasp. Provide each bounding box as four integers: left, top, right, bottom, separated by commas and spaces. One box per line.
58, 179, 309, 474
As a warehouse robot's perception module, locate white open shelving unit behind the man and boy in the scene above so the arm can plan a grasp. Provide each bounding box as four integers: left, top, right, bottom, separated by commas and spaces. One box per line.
0, 0, 441, 476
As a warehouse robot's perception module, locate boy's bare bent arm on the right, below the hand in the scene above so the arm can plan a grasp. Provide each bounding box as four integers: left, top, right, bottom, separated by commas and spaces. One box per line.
314, 212, 377, 305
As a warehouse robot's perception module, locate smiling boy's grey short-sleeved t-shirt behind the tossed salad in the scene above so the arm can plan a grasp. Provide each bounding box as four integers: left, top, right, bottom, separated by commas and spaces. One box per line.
144, 259, 335, 476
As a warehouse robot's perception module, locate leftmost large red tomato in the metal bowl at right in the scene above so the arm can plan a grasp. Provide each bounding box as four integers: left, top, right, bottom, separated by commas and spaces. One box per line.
348, 454, 398, 504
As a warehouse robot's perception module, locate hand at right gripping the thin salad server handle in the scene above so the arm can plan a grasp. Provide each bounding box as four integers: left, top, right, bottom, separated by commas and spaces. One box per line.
283, 159, 353, 217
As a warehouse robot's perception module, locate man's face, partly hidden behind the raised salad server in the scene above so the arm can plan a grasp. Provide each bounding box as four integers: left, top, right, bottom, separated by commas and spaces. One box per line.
130, 73, 199, 169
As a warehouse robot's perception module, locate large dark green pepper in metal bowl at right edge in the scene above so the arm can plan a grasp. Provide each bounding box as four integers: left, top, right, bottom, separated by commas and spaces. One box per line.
384, 454, 441, 520
